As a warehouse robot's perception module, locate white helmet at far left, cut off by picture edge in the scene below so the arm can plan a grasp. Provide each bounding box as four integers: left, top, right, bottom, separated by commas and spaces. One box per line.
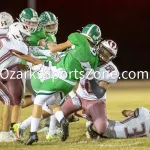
0, 12, 14, 29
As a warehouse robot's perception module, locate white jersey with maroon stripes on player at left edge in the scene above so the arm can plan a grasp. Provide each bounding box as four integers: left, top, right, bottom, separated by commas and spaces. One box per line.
0, 37, 28, 70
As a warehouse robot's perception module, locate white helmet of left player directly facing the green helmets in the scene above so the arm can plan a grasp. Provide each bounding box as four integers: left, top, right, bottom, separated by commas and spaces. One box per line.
7, 22, 31, 42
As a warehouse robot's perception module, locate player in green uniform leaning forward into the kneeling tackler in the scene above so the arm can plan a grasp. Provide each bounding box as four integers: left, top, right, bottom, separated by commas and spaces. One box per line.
12, 24, 101, 145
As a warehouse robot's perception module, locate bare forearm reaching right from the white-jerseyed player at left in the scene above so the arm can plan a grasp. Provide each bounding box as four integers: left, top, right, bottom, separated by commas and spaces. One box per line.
12, 52, 43, 65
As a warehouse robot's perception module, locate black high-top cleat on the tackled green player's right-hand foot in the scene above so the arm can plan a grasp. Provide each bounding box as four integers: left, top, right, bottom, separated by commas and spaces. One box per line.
60, 118, 69, 141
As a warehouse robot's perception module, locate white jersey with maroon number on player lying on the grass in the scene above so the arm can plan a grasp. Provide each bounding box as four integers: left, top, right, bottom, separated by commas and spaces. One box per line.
104, 107, 150, 138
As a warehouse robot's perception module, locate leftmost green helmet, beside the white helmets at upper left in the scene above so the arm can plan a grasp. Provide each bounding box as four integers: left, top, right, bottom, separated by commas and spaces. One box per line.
19, 8, 38, 33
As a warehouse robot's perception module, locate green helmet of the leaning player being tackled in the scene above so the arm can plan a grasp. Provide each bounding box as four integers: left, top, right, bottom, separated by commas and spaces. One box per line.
81, 24, 101, 46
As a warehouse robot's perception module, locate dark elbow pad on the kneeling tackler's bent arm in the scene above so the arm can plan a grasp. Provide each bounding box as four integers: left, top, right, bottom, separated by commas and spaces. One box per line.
89, 79, 106, 99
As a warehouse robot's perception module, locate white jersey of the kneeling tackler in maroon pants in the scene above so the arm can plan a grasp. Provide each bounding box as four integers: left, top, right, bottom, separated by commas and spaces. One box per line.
76, 61, 119, 100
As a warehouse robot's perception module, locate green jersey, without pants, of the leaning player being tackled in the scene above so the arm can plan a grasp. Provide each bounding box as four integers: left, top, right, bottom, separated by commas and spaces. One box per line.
56, 33, 99, 81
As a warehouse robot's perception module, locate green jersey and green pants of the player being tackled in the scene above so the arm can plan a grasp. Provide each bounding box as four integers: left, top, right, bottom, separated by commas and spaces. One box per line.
33, 33, 99, 95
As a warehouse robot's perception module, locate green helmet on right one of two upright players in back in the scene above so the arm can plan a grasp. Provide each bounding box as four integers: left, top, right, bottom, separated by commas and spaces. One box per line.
39, 11, 58, 34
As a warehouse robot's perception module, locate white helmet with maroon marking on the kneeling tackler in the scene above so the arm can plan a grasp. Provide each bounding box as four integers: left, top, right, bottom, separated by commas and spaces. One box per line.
97, 40, 118, 63
